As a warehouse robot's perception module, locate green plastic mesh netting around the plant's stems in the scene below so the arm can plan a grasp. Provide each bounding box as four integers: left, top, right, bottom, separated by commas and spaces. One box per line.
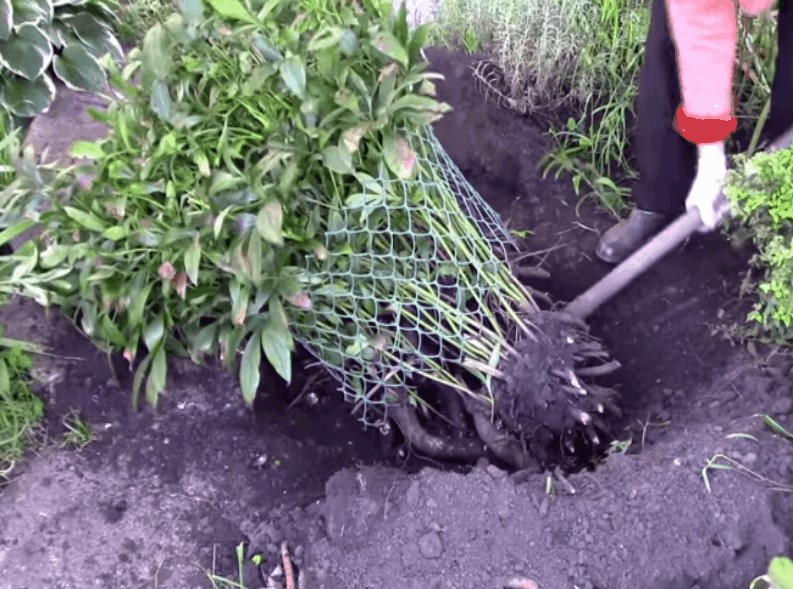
294, 126, 536, 425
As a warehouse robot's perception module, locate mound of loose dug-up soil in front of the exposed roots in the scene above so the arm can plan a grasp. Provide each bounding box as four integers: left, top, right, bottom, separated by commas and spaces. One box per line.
241, 356, 793, 589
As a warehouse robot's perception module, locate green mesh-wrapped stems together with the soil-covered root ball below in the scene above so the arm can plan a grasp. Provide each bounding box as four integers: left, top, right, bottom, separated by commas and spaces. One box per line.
294, 129, 617, 466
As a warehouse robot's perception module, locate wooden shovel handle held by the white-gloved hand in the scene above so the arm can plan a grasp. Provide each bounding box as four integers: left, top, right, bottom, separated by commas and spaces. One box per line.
563, 121, 793, 321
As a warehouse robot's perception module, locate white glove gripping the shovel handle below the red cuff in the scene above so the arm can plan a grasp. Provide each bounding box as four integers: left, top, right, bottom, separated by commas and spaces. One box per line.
686, 141, 730, 233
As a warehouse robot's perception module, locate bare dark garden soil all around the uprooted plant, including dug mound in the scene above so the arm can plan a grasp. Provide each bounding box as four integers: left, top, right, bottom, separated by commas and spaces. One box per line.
0, 51, 793, 589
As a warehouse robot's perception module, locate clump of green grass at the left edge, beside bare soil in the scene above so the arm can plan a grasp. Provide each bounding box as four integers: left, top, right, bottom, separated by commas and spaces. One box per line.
0, 328, 44, 482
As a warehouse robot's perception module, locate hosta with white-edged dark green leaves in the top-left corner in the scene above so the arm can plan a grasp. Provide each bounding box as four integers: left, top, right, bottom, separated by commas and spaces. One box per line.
0, 0, 122, 118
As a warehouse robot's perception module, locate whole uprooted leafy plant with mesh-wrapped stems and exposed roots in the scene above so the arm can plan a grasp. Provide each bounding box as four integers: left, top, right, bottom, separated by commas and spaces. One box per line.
5, 0, 616, 466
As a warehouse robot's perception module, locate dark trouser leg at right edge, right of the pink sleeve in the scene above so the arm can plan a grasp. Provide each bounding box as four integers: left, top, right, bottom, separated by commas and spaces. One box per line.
763, 0, 793, 141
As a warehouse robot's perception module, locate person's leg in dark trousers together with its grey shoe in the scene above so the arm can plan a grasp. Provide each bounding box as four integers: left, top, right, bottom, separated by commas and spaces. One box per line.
596, 0, 696, 264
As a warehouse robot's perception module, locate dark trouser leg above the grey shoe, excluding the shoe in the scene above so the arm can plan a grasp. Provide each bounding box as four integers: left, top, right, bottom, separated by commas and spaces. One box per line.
633, 0, 696, 215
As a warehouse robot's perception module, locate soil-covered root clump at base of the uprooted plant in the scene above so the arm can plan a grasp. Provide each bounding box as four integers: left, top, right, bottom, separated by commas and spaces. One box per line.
388, 312, 620, 470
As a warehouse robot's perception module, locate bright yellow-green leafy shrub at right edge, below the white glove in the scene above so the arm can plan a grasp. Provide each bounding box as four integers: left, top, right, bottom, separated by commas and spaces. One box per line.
725, 144, 793, 344
